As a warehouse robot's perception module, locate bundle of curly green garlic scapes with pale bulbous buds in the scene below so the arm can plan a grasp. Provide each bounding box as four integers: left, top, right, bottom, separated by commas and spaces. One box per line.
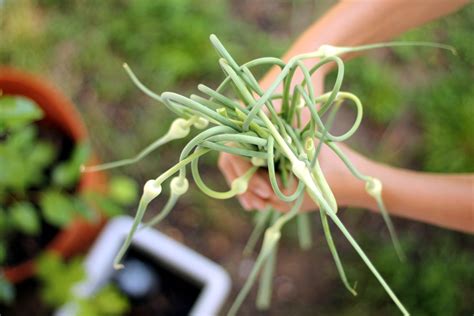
83, 35, 454, 315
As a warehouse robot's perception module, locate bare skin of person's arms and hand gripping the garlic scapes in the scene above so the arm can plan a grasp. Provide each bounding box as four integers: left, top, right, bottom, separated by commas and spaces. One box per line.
219, 0, 474, 233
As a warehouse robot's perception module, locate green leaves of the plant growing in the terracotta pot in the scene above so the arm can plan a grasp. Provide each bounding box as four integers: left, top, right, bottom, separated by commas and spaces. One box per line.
0, 96, 83, 237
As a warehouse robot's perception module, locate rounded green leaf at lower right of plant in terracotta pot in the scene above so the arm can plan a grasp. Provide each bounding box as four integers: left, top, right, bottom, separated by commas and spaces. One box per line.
40, 190, 75, 227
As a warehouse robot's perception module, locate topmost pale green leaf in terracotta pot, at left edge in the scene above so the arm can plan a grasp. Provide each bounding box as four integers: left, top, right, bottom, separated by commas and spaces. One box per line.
0, 96, 43, 131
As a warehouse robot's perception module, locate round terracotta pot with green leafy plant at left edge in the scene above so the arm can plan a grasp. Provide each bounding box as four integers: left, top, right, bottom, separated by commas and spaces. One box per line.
0, 68, 106, 294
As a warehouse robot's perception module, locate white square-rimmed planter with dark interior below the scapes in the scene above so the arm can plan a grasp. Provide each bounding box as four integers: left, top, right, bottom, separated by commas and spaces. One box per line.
58, 216, 230, 316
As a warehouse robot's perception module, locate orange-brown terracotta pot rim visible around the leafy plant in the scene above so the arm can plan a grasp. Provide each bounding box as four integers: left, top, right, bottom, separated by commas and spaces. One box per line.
0, 68, 106, 283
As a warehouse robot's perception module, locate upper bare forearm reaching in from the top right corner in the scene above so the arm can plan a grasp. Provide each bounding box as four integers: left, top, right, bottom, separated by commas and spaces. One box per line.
261, 0, 469, 87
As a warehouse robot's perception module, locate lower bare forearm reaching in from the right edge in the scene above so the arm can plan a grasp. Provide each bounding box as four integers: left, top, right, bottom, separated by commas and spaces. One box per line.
348, 162, 474, 233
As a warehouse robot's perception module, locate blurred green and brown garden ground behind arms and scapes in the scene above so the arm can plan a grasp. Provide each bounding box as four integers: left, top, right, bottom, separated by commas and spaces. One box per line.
0, 0, 474, 315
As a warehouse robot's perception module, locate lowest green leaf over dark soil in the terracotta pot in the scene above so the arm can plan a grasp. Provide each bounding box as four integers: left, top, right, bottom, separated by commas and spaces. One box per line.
9, 202, 41, 235
